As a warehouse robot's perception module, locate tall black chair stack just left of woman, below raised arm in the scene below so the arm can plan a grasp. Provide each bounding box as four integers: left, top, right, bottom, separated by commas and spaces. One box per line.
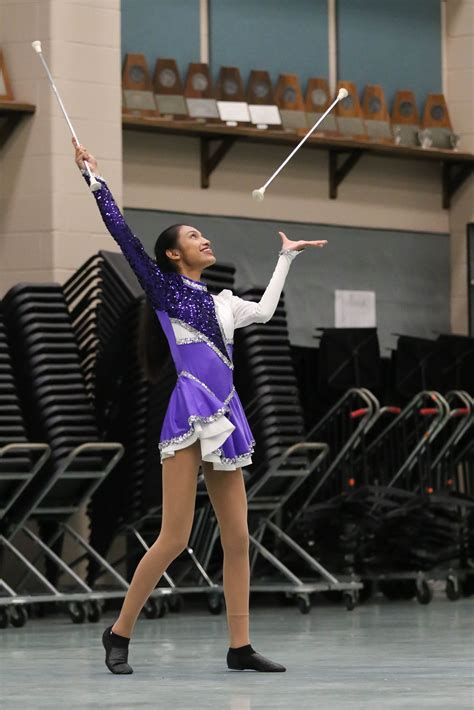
63, 251, 148, 584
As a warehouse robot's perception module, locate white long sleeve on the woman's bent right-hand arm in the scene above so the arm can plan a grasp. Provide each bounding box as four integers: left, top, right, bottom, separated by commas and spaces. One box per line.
231, 249, 303, 328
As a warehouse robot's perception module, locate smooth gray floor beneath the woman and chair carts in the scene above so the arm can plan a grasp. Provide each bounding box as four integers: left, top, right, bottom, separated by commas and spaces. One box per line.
0, 595, 474, 710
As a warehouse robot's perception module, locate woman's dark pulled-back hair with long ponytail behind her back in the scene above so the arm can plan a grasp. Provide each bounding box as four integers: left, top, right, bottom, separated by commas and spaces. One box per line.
138, 224, 183, 383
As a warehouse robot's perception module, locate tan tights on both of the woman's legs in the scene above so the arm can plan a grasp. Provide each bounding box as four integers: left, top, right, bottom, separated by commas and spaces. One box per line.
112, 441, 250, 648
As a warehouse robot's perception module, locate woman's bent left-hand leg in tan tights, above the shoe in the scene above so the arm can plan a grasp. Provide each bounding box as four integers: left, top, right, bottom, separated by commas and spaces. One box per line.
112, 441, 201, 638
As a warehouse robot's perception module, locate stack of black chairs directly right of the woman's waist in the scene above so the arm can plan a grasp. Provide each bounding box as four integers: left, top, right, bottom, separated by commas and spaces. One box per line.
235, 288, 305, 474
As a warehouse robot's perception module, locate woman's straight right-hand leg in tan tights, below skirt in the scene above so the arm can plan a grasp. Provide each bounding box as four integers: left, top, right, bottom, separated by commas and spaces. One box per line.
202, 461, 250, 648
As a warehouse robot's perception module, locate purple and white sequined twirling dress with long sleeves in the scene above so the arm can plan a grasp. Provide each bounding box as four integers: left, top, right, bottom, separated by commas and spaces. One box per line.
84, 174, 300, 471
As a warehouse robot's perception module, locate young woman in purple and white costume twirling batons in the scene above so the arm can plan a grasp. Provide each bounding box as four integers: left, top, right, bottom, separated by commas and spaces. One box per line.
73, 139, 327, 674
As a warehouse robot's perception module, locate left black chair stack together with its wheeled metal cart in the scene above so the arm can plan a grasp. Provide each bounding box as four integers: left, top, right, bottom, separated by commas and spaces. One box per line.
3, 284, 127, 621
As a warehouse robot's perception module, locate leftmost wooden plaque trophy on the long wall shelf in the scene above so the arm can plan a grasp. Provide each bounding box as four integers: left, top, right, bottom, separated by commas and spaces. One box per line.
122, 54, 158, 118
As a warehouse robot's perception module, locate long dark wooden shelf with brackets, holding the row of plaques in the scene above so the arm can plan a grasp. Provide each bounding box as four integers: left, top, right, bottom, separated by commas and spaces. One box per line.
122, 115, 474, 209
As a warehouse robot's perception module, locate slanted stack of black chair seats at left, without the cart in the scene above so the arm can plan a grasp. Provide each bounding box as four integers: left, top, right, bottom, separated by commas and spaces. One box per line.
3, 283, 99, 472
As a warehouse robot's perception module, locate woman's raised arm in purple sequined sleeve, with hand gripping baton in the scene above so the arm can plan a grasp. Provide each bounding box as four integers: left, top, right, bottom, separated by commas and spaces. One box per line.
73, 141, 169, 310
